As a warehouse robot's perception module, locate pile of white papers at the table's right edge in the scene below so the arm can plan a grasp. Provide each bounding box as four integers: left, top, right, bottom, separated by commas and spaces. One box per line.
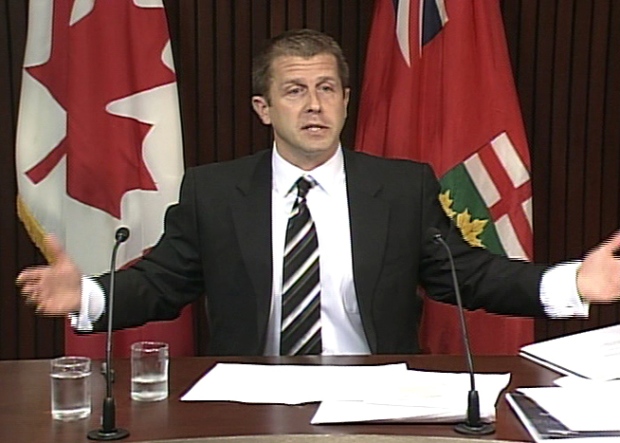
506, 325, 620, 443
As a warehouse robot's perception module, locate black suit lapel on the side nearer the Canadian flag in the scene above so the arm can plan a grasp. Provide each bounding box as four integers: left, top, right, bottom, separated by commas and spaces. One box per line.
232, 150, 273, 352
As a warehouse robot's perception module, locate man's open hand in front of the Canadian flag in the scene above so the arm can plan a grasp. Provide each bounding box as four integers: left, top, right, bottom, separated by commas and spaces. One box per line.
17, 236, 82, 316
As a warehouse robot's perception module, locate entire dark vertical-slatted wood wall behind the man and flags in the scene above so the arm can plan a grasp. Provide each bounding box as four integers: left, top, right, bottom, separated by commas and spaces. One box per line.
0, 0, 620, 359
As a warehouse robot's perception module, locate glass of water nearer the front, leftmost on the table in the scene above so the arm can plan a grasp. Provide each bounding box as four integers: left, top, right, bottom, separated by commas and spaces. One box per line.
50, 357, 91, 421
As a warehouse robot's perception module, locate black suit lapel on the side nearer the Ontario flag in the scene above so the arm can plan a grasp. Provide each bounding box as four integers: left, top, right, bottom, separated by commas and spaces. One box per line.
344, 150, 389, 352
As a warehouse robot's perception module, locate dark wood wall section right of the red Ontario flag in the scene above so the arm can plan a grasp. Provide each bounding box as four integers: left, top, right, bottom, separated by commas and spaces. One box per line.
502, 0, 620, 339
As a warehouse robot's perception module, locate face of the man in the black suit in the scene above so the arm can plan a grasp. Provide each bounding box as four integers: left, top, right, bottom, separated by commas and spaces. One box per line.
252, 54, 349, 170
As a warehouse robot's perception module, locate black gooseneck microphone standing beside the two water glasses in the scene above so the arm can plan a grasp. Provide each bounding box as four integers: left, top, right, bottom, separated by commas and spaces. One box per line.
87, 226, 129, 441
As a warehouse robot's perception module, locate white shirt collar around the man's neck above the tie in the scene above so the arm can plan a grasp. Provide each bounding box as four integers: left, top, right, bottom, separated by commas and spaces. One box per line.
271, 144, 344, 196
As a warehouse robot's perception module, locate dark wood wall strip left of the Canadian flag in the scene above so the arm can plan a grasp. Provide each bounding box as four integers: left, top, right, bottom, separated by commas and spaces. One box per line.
0, 0, 63, 359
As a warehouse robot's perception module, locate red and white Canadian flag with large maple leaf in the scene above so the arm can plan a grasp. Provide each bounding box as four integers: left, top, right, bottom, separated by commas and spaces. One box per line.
16, 0, 194, 358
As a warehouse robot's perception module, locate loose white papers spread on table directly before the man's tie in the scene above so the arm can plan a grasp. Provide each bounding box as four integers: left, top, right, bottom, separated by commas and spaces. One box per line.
181, 363, 510, 424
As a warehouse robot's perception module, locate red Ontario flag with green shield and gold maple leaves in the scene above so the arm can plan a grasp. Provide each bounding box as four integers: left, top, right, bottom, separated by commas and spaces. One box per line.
356, 0, 533, 354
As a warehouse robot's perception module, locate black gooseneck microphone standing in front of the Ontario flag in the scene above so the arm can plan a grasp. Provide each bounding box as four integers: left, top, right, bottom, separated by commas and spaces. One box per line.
428, 228, 495, 435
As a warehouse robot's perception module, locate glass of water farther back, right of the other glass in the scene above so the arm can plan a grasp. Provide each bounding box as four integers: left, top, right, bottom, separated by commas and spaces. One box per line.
131, 341, 169, 401
